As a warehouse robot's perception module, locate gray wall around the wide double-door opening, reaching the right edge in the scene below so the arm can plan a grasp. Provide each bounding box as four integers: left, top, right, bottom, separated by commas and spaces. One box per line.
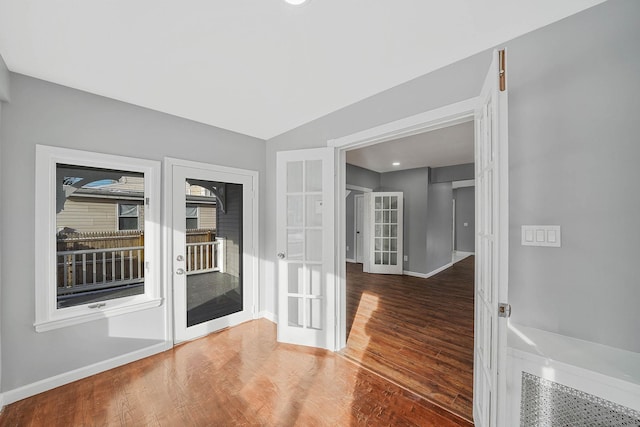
265, 0, 640, 352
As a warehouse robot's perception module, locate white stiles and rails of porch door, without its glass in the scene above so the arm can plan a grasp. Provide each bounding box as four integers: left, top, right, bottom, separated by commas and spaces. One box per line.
165, 159, 258, 343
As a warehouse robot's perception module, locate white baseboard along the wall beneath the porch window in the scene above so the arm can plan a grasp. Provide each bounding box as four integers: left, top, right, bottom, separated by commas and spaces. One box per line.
2, 342, 173, 405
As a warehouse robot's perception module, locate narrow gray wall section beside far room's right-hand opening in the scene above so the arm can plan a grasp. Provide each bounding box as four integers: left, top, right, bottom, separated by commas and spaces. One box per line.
426, 182, 453, 272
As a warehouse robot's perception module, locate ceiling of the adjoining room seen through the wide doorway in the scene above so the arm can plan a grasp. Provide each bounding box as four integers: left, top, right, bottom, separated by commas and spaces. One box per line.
347, 121, 474, 173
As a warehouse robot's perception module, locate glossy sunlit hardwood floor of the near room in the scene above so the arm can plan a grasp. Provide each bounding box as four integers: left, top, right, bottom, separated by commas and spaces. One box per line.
0, 316, 471, 427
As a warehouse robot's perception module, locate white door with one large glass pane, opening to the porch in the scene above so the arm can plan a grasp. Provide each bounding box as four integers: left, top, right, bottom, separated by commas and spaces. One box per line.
172, 162, 257, 342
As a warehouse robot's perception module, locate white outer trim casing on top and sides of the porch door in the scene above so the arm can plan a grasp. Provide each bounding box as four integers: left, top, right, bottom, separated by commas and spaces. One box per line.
162, 157, 260, 344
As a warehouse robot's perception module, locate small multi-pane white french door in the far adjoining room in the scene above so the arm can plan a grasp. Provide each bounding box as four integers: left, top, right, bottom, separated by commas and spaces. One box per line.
367, 192, 403, 274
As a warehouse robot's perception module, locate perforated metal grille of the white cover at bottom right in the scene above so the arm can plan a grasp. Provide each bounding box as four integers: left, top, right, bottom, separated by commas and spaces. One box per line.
520, 372, 640, 427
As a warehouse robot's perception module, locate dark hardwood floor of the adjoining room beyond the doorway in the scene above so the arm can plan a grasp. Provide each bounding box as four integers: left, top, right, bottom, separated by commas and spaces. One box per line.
342, 256, 474, 421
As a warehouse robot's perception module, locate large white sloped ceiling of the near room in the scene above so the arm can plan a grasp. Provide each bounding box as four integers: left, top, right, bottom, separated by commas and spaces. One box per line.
0, 0, 603, 139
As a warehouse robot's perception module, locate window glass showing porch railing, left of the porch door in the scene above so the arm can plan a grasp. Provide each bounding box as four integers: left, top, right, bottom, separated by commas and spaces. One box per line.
56, 164, 145, 308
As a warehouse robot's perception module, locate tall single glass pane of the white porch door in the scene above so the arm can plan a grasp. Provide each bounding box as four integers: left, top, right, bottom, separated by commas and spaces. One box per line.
184, 178, 243, 327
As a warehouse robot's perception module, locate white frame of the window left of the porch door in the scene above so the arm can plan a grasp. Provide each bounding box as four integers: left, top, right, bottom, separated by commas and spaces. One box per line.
34, 145, 162, 332
